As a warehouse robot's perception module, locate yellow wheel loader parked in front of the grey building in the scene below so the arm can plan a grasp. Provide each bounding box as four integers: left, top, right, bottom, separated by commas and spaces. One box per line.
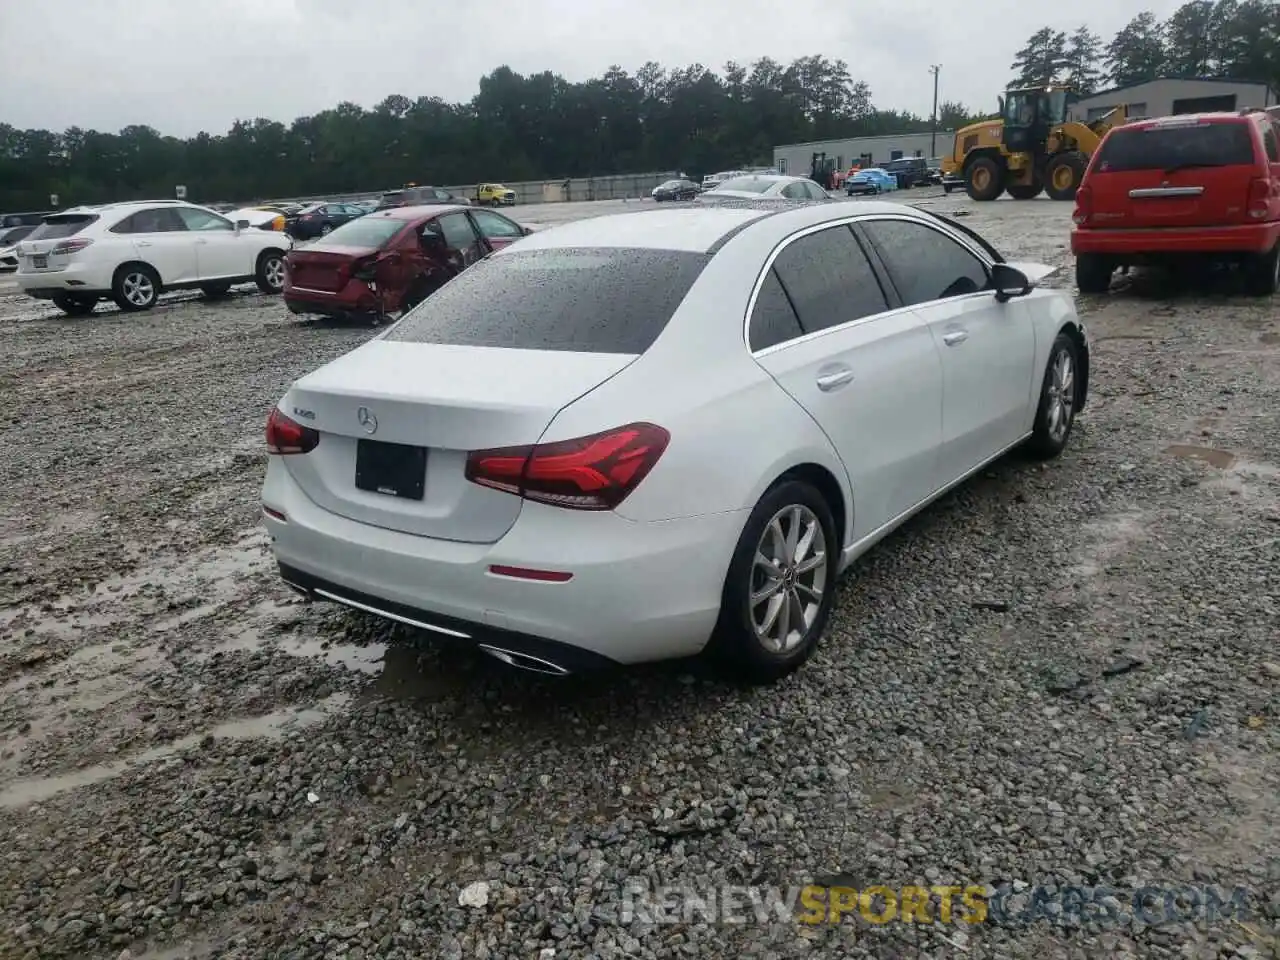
942, 86, 1128, 200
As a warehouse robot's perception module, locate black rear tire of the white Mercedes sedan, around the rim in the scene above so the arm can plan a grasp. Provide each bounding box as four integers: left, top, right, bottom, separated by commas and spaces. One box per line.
708, 480, 840, 685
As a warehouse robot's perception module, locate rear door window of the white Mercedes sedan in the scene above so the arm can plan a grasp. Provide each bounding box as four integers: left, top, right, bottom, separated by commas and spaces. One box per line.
773, 225, 888, 333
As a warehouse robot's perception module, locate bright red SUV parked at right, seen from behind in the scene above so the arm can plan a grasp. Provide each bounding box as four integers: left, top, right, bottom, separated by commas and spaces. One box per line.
1071, 110, 1280, 297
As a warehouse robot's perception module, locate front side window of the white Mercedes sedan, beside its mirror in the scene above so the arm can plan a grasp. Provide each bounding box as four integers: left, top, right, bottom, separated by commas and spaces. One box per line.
861, 220, 989, 306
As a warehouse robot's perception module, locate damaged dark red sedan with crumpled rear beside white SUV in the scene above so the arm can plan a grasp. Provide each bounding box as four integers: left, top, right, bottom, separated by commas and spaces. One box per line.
284, 205, 531, 319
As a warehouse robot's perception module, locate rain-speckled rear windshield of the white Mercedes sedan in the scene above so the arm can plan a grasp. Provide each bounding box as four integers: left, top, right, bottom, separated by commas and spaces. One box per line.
384, 248, 710, 353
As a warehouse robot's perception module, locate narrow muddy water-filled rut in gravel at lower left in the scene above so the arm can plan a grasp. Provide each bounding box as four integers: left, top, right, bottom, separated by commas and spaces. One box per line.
0, 694, 351, 809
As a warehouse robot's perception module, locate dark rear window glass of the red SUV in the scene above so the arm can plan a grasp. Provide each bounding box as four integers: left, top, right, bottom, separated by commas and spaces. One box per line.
1096, 122, 1253, 173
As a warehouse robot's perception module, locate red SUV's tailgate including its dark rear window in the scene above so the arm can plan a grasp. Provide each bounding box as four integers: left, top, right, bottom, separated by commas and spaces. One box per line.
1088, 118, 1261, 229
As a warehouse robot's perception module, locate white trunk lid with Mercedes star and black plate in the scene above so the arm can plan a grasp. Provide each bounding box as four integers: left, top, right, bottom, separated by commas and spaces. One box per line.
280, 339, 634, 543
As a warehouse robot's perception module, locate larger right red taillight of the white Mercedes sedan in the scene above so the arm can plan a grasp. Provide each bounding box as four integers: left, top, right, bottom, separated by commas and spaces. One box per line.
466, 424, 671, 509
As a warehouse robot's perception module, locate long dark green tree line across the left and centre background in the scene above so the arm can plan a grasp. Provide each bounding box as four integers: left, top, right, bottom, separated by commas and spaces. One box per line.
0, 55, 995, 211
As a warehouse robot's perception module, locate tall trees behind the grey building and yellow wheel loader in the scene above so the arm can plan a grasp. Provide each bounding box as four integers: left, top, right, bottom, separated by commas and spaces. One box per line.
1010, 0, 1280, 95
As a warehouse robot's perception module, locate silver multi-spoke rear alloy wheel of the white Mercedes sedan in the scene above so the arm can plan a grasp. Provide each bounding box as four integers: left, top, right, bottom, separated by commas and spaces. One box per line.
748, 504, 828, 654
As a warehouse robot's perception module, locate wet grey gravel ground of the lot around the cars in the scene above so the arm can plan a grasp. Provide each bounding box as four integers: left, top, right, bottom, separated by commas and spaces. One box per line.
0, 189, 1280, 960
